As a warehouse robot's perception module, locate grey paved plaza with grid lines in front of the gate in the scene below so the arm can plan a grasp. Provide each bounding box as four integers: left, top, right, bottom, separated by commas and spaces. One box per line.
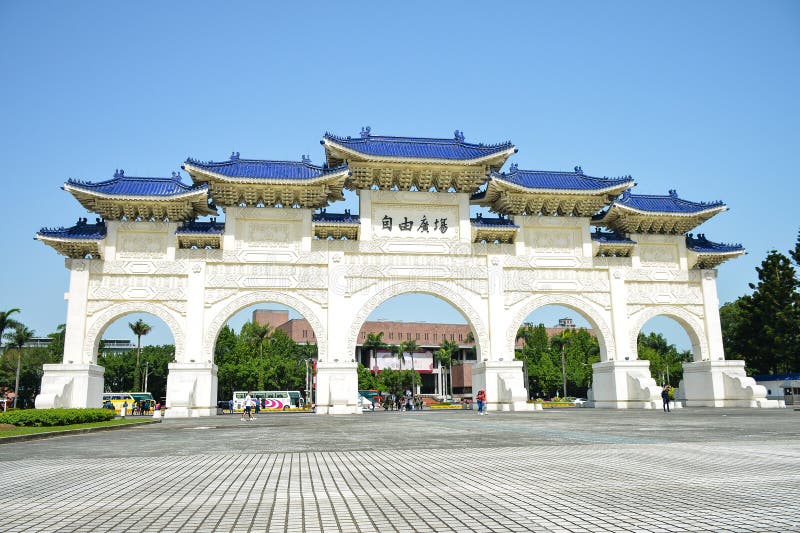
0, 409, 800, 532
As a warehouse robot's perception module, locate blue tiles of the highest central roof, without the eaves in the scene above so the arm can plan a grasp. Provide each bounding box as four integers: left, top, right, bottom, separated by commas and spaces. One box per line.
320, 128, 516, 161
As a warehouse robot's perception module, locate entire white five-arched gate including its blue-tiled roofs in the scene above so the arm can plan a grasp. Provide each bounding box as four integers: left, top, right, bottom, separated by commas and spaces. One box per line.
37, 128, 777, 417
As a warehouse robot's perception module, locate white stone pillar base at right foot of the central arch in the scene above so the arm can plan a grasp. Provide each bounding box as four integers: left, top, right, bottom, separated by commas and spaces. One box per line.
472, 361, 537, 411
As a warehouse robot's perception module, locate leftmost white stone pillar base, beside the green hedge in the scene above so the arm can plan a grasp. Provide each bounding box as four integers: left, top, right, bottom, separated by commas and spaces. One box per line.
34, 364, 106, 409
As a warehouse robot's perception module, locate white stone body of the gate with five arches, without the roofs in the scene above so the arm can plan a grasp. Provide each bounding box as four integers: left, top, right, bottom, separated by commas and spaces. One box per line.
37, 190, 776, 416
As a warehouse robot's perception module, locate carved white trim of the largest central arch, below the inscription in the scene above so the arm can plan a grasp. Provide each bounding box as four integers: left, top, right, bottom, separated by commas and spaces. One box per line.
345, 281, 490, 361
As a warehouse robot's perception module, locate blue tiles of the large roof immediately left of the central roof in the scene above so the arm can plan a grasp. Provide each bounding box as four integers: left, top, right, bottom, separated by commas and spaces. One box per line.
186, 153, 347, 180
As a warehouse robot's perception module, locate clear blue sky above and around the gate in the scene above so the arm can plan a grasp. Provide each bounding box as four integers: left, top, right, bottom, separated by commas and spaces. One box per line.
0, 1, 800, 354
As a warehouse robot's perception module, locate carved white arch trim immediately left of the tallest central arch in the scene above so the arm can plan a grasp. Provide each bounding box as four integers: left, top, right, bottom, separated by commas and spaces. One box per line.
203, 290, 328, 361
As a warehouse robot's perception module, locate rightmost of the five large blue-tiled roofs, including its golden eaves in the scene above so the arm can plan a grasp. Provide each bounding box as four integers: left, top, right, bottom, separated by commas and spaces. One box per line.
592, 190, 727, 235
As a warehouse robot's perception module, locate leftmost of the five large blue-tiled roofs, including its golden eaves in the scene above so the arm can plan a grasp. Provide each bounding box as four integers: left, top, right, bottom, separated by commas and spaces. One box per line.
63, 169, 216, 220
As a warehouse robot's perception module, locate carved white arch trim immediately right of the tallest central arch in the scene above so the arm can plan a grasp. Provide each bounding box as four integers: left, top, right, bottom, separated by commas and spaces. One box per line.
506, 294, 617, 361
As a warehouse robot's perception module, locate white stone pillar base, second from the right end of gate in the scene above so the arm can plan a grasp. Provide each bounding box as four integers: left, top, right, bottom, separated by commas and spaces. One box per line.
592, 360, 661, 409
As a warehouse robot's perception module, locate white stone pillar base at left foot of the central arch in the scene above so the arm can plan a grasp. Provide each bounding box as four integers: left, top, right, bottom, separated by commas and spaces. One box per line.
315, 361, 361, 415
